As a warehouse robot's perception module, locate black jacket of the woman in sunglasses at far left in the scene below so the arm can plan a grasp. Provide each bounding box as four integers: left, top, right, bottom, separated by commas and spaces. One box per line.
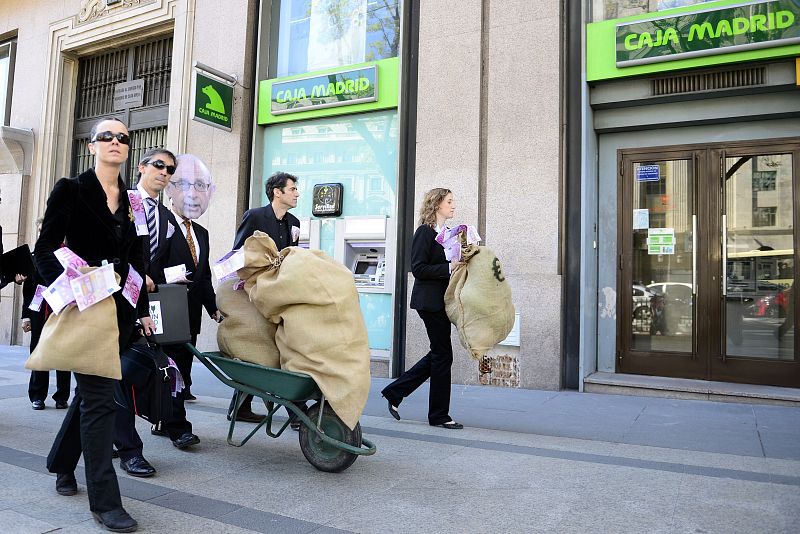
33, 169, 148, 348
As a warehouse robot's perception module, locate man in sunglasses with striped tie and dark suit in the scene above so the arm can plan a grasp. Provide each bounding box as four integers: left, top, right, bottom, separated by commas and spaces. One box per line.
114, 148, 177, 477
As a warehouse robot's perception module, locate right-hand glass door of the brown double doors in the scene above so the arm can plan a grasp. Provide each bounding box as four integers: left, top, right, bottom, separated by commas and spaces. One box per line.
710, 143, 800, 387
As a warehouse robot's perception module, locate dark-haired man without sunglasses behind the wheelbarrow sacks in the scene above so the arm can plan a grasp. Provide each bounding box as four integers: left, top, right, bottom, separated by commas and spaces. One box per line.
228, 172, 300, 426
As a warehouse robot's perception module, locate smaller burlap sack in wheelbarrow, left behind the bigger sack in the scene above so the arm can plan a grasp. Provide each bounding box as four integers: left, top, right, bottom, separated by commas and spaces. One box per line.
217, 280, 281, 368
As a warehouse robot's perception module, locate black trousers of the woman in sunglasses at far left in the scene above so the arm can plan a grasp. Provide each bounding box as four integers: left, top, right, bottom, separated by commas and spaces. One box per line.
47, 373, 122, 512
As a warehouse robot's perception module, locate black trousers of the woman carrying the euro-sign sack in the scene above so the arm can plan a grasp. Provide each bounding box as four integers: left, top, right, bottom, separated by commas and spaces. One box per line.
381, 310, 453, 425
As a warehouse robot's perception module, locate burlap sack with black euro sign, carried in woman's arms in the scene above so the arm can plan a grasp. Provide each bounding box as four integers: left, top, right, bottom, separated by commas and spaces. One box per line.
444, 245, 514, 360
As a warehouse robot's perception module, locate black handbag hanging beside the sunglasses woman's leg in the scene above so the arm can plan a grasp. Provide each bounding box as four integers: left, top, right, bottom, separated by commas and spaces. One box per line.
114, 339, 178, 430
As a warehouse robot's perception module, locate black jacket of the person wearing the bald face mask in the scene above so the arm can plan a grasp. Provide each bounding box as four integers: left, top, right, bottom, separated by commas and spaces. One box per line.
162, 217, 217, 336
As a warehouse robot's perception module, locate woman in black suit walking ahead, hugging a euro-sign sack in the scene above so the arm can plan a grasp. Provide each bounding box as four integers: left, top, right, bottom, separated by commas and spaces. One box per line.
381, 188, 464, 429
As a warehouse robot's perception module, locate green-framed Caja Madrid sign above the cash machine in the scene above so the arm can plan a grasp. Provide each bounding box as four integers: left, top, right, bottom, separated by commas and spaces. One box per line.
258, 57, 400, 124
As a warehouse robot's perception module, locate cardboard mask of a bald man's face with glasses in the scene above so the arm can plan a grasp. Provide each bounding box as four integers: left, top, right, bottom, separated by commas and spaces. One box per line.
166, 154, 216, 219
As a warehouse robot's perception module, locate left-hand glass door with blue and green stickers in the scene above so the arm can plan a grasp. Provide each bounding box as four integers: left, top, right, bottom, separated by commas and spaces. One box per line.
618, 151, 705, 377
